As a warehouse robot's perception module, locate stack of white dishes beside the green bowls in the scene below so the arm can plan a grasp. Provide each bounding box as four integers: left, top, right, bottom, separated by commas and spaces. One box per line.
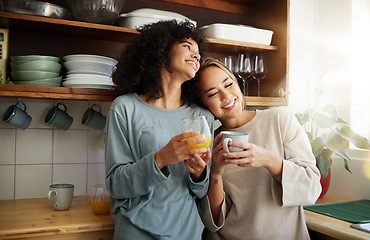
62, 54, 117, 89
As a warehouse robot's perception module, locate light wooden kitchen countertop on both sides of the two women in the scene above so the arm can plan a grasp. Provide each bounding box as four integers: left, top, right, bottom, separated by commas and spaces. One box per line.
0, 194, 370, 240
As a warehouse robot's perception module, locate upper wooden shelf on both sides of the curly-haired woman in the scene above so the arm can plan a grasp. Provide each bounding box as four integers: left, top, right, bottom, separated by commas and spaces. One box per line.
0, 12, 278, 53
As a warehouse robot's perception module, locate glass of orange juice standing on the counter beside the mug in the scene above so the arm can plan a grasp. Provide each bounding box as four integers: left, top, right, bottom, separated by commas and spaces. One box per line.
89, 184, 110, 215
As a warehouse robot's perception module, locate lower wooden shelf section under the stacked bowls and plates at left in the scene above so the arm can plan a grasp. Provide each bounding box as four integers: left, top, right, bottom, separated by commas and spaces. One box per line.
0, 84, 118, 101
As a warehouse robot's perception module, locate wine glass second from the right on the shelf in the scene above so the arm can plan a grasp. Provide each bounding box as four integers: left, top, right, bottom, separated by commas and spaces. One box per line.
234, 53, 252, 96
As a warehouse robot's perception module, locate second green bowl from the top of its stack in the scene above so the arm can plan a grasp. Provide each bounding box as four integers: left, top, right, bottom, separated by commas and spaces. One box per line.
12, 60, 62, 73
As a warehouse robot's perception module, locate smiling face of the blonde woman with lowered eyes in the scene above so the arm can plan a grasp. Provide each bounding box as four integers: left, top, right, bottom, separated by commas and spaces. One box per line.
199, 66, 244, 122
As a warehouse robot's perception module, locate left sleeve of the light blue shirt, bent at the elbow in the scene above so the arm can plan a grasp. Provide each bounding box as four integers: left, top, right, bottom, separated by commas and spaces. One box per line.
105, 110, 169, 199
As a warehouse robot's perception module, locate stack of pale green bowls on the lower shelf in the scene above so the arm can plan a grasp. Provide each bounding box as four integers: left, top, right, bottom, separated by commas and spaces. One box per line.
10, 55, 62, 87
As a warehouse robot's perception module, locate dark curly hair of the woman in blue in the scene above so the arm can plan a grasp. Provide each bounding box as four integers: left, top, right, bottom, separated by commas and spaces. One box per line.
113, 20, 205, 100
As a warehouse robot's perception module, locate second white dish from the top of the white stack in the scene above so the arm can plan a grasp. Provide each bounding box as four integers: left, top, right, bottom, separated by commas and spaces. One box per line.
64, 61, 116, 76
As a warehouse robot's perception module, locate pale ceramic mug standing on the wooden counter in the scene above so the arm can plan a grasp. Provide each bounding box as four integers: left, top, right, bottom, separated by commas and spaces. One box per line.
48, 183, 74, 211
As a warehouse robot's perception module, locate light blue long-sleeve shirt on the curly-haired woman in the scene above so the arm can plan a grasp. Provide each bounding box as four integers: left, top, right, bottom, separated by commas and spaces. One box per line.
106, 94, 214, 240
